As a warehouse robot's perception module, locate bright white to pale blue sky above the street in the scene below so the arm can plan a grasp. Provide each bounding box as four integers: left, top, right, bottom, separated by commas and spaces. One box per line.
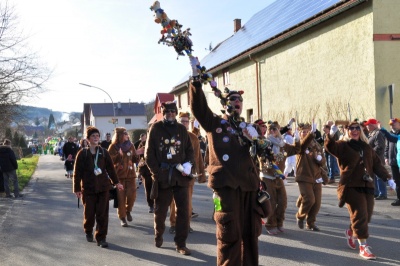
7, 0, 275, 112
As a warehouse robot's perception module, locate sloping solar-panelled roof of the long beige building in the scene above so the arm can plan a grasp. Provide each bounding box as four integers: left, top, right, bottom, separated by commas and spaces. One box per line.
172, 0, 365, 89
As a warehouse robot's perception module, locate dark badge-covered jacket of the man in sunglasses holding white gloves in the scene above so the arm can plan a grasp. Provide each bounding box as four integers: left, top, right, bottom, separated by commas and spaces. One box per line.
144, 121, 194, 188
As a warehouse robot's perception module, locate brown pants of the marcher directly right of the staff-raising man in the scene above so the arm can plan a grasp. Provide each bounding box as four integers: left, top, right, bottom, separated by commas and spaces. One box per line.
263, 178, 287, 230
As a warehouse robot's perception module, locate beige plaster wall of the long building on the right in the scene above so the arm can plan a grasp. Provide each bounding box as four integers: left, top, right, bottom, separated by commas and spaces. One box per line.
182, 0, 400, 126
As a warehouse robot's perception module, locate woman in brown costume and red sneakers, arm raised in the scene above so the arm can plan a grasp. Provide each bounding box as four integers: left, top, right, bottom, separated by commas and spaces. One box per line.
324, 121, 390, 260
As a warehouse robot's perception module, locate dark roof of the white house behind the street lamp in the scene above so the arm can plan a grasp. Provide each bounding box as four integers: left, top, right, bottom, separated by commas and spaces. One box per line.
90, 103, 146, 117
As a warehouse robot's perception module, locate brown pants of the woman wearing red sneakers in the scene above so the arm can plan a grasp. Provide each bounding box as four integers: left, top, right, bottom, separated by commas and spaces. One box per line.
346, 188, 375, 239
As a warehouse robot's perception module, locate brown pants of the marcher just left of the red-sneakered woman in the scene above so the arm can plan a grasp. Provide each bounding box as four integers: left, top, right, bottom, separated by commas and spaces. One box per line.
296, 182, 322, 227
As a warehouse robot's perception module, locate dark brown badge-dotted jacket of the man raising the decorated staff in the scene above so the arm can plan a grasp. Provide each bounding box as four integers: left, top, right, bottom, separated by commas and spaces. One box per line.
189, 82, 260, 192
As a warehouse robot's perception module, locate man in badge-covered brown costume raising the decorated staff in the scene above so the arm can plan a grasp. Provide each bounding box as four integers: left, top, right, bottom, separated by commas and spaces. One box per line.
189, 57, 267, 265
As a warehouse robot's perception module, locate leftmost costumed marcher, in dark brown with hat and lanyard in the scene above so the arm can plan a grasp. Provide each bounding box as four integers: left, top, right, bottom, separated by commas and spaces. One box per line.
72, 126, 124, 248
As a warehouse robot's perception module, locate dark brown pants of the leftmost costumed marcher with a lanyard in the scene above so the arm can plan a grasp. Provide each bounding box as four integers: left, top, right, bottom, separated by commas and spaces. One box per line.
82, 190, 109, 242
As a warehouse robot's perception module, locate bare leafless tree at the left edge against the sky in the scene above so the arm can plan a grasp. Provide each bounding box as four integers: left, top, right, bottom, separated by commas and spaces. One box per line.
0, 2, 51, 130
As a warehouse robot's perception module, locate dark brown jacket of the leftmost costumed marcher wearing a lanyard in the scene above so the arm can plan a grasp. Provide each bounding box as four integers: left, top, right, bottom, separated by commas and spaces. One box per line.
73, 146, 118, 193
